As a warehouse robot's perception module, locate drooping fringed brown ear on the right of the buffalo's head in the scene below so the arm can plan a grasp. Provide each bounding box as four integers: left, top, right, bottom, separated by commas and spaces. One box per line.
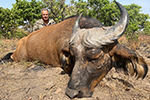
110, 43, 148, 79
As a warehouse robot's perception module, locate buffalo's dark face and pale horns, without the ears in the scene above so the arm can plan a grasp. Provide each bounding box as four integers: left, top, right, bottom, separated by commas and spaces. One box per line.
66, 2, 128, 98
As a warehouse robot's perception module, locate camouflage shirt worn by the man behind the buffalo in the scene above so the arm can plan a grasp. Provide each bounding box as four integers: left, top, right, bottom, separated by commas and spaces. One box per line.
33, 19, 56, 31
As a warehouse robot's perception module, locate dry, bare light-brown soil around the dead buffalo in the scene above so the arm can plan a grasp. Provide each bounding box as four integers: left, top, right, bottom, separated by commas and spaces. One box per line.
0, 37, 150, 100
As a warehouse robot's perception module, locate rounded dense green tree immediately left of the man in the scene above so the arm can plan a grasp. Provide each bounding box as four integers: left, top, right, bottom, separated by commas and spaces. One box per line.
12, 0, 44, 32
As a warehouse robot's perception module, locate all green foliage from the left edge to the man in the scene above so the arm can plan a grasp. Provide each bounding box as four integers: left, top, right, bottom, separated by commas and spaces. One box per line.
0, 0, 43, 38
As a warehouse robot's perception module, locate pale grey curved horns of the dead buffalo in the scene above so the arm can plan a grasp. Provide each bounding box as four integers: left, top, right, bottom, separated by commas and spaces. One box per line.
72, 1, 129, 48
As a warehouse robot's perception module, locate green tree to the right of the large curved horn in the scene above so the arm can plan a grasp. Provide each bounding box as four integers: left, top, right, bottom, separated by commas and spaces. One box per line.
125, 4, 150, 39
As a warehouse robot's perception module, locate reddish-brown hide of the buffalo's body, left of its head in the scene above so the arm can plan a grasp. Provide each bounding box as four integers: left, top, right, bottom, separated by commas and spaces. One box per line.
11, 17, 76, 67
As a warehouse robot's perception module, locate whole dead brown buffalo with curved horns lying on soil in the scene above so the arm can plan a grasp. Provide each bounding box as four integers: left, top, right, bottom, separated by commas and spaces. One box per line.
1, 2, 148, 98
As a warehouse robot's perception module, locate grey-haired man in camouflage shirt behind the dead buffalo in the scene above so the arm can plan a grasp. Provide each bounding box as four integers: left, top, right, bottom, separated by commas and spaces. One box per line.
33, 8, 56, 31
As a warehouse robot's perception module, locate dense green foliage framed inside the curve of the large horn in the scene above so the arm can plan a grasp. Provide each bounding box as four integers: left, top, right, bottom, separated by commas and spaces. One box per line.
88, 0, 119, 26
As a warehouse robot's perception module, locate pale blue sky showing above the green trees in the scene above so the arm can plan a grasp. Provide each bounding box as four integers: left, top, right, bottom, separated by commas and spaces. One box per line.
0, 0, 150, 16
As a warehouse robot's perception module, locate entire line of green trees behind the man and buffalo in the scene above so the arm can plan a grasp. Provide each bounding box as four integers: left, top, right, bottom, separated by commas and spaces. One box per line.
0, 0, 150, 39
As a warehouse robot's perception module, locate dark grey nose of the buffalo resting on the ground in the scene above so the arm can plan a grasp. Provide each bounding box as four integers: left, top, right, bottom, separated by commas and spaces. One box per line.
65, 87, 83, 99
